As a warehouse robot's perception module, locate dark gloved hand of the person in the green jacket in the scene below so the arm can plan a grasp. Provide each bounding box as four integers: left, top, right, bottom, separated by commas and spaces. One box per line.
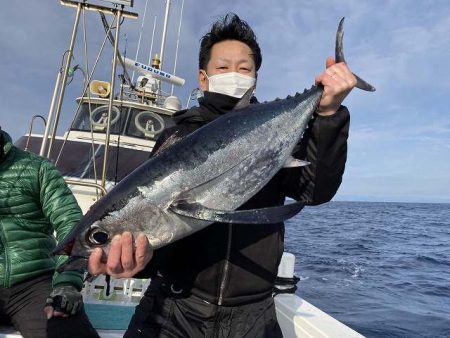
44, 285, 83, 319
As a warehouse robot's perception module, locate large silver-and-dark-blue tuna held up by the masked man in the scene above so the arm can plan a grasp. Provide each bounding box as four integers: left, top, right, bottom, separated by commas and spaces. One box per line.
54, 20, 374, 270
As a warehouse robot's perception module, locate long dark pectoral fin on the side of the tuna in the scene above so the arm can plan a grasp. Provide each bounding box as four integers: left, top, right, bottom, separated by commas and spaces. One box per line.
169, 201, 305, 224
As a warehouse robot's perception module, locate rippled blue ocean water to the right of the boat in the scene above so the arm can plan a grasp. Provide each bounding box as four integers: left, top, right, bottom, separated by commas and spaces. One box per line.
285, 202, 450, 338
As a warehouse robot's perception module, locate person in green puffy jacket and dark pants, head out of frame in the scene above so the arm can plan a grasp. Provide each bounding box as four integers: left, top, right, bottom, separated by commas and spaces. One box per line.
0, 128, 99, 338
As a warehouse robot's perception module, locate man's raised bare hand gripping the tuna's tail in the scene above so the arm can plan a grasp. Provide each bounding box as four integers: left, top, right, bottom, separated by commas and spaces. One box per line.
316, 57, 356, 116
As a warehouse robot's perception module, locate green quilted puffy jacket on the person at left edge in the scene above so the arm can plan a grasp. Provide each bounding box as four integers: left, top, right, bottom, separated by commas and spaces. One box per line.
0, 129, 83, 290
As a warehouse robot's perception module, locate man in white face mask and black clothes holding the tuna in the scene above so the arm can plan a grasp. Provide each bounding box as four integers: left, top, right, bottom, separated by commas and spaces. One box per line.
85, 14, 370, 337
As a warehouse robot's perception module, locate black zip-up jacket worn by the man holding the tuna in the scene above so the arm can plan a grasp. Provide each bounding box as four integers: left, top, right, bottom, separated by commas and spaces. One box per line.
137, 92, 350, 306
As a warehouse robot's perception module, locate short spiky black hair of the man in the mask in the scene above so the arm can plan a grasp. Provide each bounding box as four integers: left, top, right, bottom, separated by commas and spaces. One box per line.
199, 13, 262, 71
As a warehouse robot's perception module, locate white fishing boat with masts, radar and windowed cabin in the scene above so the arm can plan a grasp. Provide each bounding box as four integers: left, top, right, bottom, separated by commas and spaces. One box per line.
0, 0, 362, 338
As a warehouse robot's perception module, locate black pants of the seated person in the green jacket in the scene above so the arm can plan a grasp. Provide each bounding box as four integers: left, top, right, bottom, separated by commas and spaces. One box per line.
0, 275, 99, 338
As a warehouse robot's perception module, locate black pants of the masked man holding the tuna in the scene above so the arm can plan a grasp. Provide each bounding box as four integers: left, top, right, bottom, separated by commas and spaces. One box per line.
124, 279, 282, 338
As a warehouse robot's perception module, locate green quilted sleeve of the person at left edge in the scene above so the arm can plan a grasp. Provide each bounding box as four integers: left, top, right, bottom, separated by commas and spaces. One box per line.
39, 160, 83, 290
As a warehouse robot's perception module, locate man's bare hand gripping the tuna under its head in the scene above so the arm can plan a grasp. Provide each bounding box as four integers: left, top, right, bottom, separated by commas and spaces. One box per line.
88, 231, 153, 278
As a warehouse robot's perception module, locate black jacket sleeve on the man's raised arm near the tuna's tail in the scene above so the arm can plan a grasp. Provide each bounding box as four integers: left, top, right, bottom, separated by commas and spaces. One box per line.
283, 106, 350, 205
